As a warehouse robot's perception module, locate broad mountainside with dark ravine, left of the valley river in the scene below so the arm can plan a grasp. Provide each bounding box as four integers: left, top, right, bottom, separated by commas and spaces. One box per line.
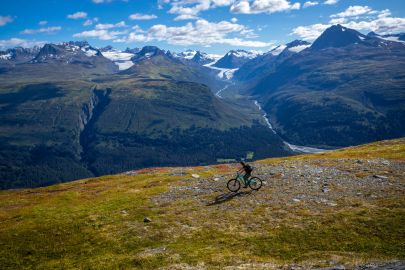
0, 42, 291, 189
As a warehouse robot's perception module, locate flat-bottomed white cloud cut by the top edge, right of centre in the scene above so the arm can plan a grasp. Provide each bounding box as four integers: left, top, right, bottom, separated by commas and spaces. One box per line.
231, 0, 301, 14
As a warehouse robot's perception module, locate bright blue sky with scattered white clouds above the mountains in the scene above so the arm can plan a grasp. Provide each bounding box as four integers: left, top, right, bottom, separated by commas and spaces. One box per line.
0, 0, 405, 54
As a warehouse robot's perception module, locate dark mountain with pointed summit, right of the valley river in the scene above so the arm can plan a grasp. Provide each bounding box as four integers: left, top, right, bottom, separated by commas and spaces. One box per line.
250, 25, 405, 148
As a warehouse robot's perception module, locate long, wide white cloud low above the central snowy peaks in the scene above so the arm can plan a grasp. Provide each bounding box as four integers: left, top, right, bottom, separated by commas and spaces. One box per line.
115, 19, 272, 47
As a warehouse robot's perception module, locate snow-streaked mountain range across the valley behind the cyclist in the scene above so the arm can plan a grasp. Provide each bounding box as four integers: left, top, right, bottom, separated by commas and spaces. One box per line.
0, 25, 405, 188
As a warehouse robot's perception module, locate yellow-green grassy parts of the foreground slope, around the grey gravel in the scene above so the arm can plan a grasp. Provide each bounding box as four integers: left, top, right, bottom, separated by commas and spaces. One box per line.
0, 139, 405, 269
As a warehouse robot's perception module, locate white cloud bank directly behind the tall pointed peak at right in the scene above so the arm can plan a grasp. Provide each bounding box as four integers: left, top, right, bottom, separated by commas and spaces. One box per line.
291, 9, 405, 40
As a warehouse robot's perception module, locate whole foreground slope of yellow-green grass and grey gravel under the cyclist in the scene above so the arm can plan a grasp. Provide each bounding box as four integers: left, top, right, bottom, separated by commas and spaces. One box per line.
0, 139, 405, 269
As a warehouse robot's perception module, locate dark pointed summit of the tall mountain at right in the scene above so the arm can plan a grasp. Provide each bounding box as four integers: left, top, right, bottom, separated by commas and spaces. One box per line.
311, 24, 366, 50
